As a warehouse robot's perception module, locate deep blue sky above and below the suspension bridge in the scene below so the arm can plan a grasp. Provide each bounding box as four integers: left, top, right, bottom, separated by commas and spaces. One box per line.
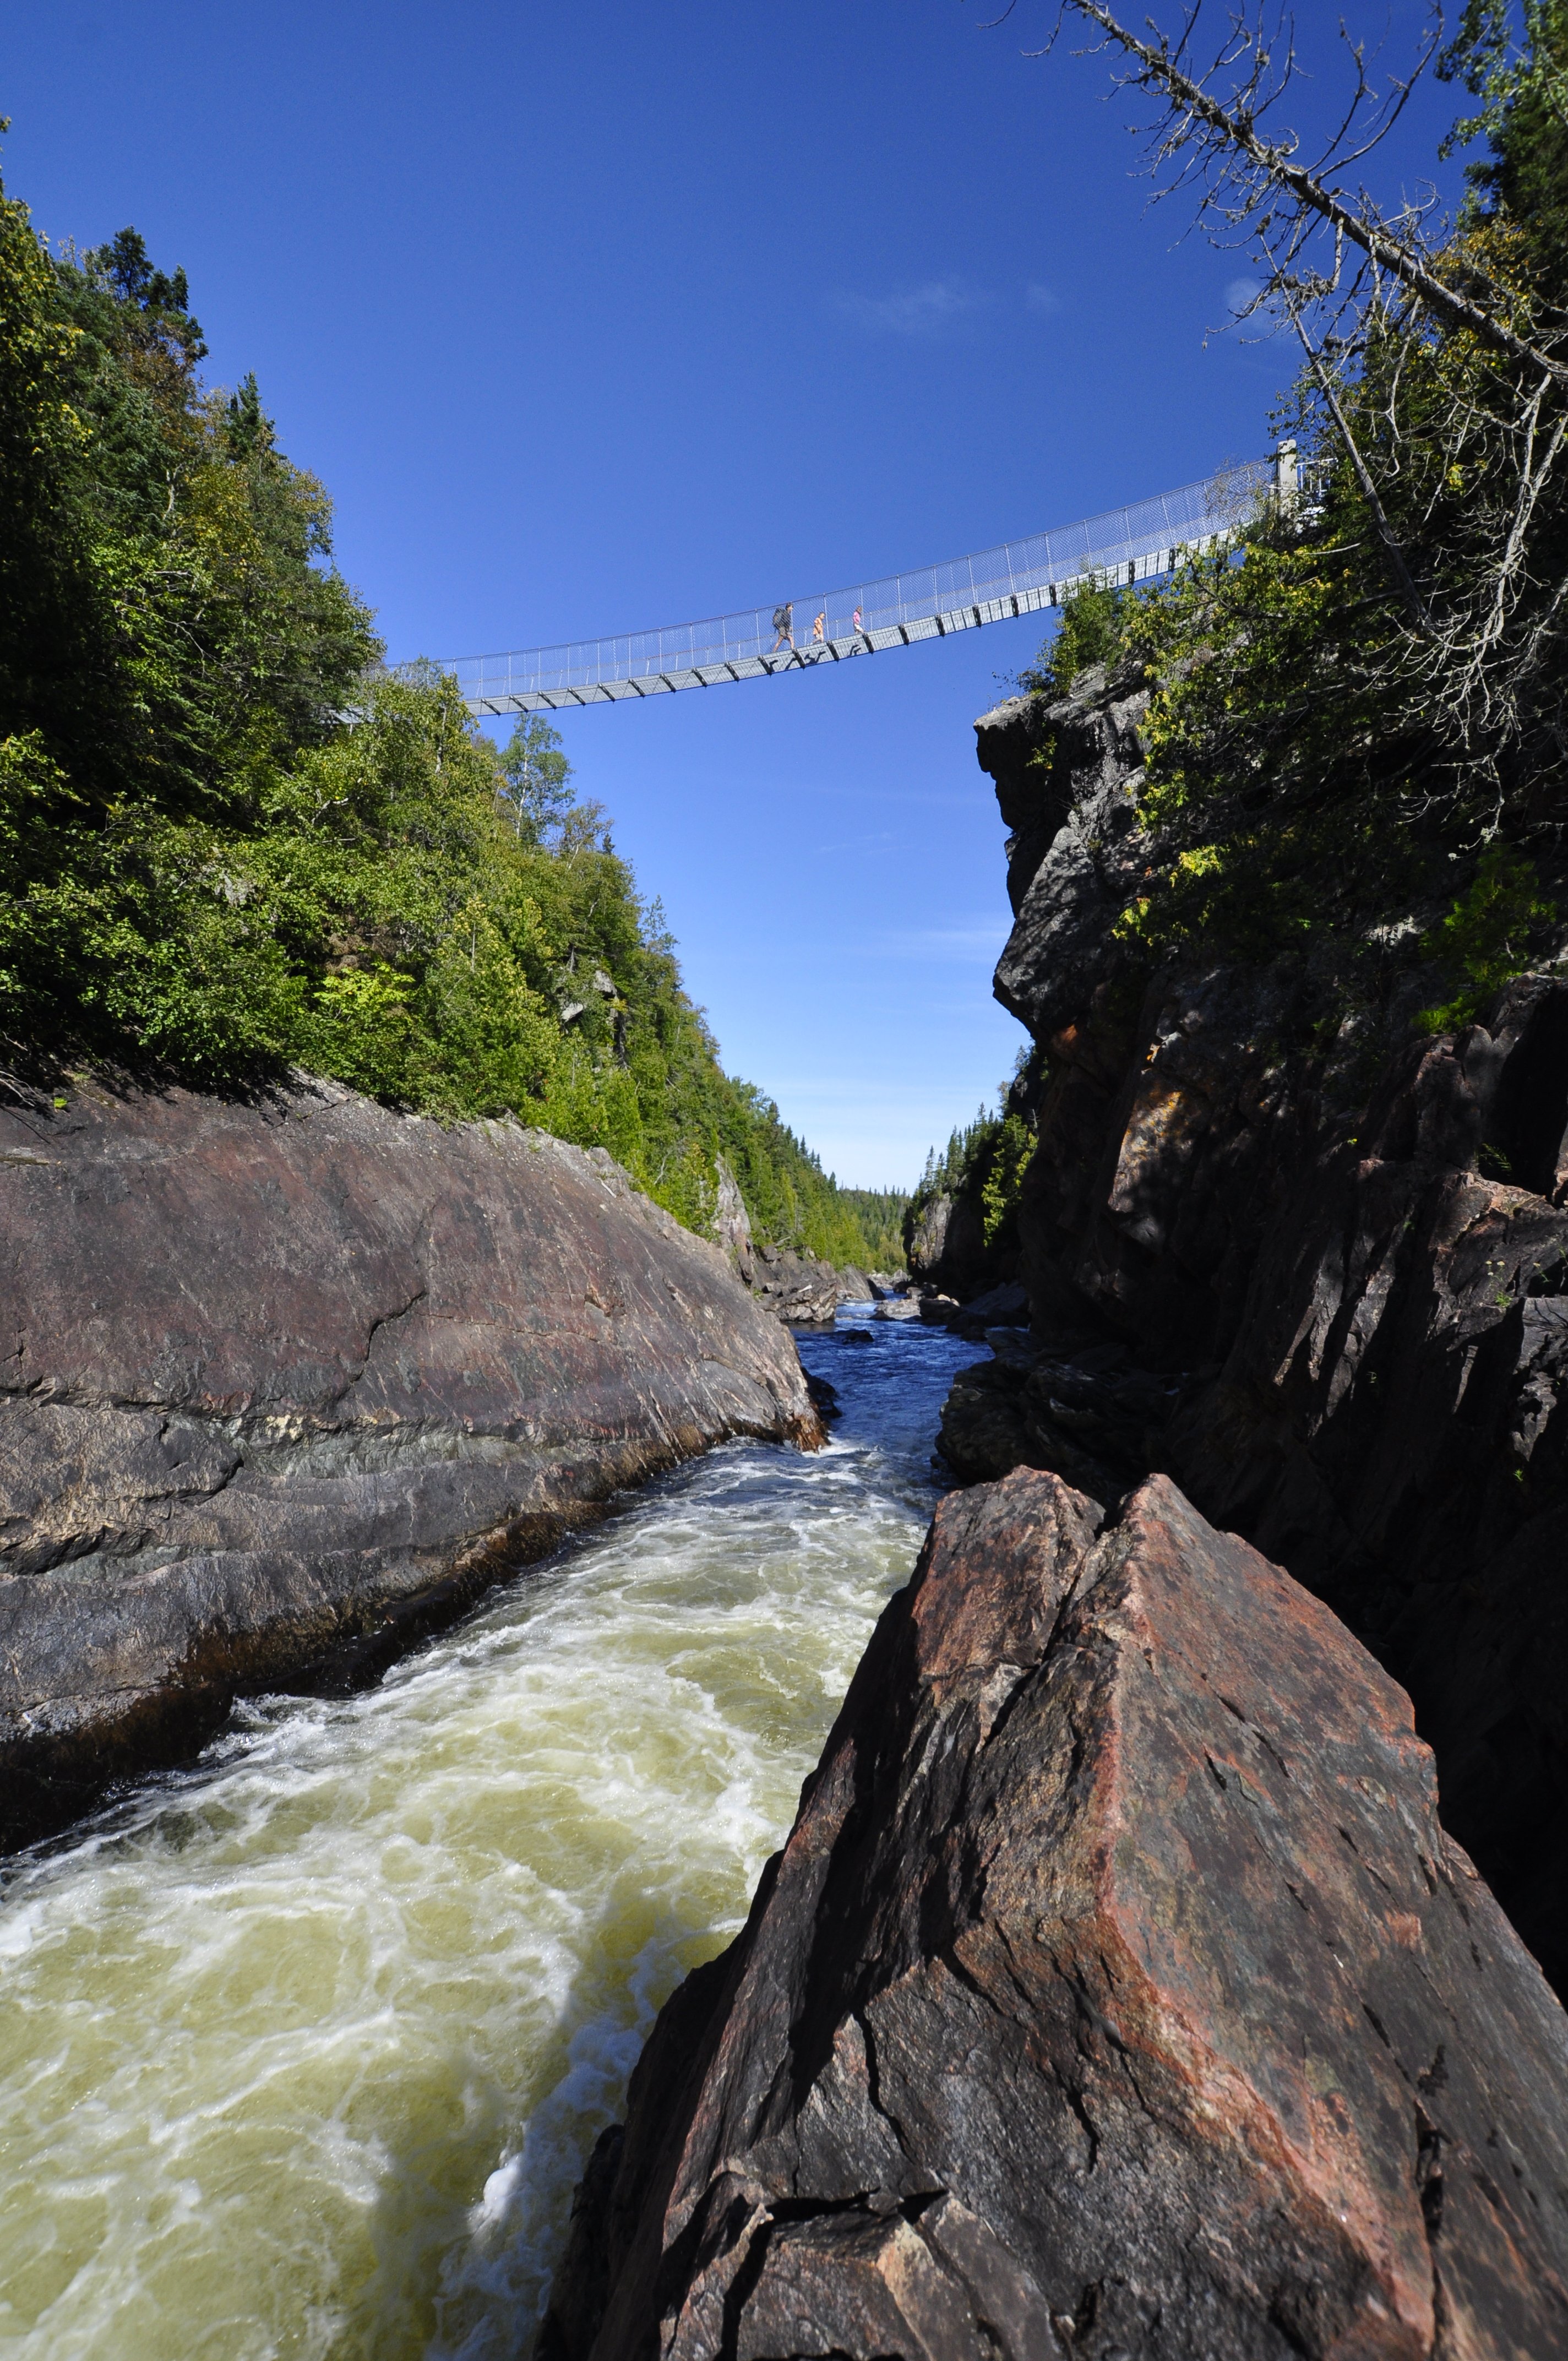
0, 0, 1452, 1185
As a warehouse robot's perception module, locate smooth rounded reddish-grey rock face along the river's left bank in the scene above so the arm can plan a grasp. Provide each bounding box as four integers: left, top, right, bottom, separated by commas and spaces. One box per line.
0, 1086, 819, 1842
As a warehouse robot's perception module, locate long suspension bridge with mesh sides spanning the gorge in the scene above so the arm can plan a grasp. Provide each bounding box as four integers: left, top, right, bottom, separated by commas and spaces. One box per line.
420, 444, 1299, 715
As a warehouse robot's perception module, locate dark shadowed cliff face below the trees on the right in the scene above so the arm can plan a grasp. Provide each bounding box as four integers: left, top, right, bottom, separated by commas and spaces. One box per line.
949, 675, 1568, 1983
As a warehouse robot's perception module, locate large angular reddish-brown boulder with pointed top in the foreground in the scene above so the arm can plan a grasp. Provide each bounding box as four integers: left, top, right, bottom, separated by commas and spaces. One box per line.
541, 1473, 1568, 2361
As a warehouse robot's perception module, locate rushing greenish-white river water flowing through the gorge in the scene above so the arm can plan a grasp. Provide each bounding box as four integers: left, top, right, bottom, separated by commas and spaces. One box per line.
0, 1315, 975, 2361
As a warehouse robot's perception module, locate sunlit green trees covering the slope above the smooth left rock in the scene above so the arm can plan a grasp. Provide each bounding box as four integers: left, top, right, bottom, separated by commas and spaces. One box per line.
0, 159, 885, 1261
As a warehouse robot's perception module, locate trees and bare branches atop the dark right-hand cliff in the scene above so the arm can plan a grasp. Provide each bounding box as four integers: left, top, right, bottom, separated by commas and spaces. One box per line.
1022, 0, 1568, 1027
